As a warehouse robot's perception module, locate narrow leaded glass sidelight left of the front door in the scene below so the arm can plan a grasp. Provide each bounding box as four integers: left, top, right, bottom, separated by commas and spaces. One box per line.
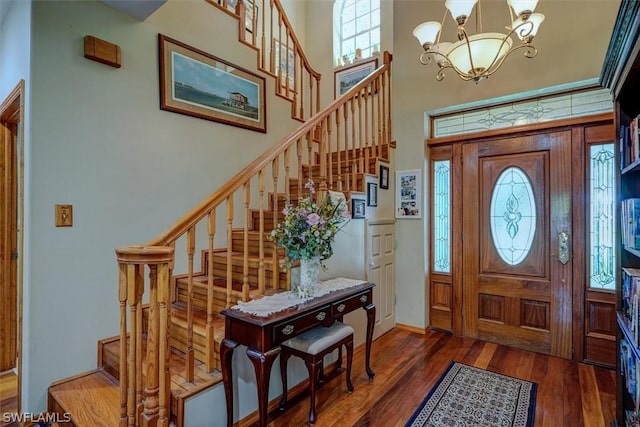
433, 160, 451, 273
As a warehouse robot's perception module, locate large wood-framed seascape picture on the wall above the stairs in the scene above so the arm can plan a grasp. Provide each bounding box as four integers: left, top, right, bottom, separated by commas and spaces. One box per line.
158, 34, 267, 133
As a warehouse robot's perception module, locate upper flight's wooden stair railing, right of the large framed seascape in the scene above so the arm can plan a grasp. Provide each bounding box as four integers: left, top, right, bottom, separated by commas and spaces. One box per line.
206, 0, 320, 121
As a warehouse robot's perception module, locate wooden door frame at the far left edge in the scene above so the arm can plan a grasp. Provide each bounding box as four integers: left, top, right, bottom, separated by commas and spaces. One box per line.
0, 80, 25, 411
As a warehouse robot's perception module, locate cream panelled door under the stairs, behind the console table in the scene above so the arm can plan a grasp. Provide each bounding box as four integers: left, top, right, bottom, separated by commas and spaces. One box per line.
366, 220, 396, 339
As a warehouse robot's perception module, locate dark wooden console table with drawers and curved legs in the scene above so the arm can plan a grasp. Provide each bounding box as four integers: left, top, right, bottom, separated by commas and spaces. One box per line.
220, 283, 376, 427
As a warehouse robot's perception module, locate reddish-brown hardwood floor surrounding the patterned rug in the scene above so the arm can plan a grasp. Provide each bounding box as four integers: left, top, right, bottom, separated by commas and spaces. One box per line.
269, 329, 615, 427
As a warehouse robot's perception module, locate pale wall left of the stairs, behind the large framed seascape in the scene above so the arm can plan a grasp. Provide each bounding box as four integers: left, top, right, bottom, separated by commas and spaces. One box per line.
19, 0, 298, 412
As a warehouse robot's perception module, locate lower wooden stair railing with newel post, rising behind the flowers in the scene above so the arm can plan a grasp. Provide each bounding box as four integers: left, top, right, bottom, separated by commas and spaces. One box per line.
116, 52, 391, 425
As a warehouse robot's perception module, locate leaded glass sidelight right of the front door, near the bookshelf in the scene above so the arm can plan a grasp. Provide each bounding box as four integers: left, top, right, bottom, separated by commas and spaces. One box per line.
589, 144, 616, 290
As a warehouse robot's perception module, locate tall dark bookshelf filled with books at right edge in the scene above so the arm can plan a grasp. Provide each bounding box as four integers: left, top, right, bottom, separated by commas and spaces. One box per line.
600, 0, 640, 427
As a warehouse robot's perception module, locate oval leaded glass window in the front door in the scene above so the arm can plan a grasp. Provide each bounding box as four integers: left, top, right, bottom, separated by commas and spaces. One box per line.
489, 166, 536, 265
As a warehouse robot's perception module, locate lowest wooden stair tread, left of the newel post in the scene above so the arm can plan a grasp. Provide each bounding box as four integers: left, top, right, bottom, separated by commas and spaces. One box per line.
49, 370, 120, 427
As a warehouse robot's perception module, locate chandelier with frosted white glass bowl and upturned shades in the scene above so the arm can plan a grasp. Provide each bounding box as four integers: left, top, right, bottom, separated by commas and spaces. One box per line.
413, 0, 544, 83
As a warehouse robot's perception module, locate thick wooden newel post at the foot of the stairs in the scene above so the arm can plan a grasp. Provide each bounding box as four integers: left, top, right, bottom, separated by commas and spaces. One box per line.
116, 246, 174, 427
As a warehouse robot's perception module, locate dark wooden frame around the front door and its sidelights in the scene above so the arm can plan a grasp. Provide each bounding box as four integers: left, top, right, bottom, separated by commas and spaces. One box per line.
425, 112, 615, 362
